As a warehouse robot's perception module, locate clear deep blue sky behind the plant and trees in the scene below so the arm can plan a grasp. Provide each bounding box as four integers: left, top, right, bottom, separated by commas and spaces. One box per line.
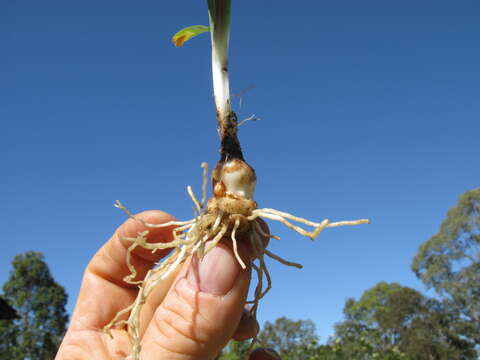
0, 0, 480, 340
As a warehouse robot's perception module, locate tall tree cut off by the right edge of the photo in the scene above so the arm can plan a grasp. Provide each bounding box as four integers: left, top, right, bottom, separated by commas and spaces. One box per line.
412, 188, 480, 345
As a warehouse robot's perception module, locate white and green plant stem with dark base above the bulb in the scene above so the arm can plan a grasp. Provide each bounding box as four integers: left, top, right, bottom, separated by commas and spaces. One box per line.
208, 0, 243, 162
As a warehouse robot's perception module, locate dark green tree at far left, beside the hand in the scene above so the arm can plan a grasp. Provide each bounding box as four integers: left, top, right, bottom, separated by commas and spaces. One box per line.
0, 251, 68, 360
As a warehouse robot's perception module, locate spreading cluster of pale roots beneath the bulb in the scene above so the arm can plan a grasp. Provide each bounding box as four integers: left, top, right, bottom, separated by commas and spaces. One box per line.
103, 163, 369, 360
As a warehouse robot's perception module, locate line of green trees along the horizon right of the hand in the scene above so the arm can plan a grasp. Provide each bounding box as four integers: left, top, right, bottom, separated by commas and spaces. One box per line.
218, 189, 480, 360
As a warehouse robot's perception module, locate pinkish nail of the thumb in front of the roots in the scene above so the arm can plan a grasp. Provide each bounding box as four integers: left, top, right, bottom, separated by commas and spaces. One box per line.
187, 245, 240, 295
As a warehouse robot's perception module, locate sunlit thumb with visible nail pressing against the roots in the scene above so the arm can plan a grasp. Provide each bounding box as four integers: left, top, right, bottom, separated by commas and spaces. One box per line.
141, 243, 250, 360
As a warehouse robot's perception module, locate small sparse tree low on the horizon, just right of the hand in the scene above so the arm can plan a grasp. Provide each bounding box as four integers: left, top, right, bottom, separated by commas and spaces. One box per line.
258, 317, 318, 360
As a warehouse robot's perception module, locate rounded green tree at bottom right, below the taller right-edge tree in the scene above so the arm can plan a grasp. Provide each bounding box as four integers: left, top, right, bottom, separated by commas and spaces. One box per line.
333, 282, 476, 360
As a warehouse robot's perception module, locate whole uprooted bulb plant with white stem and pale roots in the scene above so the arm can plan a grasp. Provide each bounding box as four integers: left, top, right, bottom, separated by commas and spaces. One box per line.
104, 0, 369, 360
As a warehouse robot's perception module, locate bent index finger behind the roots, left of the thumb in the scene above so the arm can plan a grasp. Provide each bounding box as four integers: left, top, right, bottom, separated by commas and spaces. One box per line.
70, 211, 174, 330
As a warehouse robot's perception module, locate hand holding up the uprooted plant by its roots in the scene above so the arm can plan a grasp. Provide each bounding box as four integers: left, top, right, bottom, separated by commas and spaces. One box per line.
56, 211, 278, 360
